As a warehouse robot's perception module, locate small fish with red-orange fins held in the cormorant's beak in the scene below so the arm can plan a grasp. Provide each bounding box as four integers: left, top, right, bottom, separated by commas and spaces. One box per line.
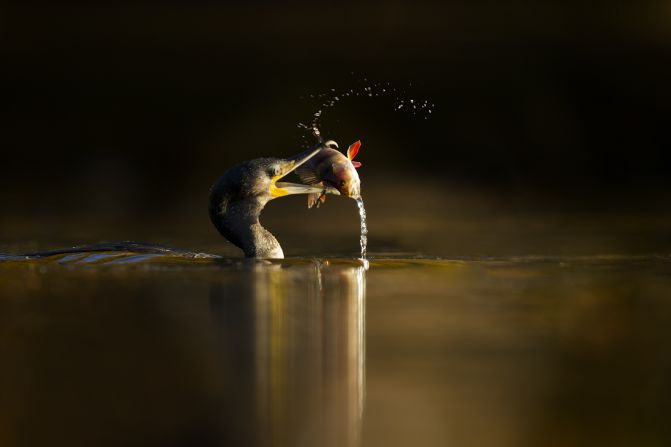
295, 140, 361, 208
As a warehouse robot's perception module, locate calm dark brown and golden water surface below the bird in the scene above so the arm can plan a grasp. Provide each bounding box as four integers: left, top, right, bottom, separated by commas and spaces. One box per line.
0, 250, 671, 446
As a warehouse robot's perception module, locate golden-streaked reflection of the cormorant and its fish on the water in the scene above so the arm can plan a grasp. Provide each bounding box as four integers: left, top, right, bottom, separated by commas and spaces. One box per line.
210, 260, 366, 446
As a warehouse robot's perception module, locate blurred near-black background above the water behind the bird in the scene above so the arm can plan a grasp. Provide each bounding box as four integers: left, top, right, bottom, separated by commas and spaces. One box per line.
0, 0, 671, 254
